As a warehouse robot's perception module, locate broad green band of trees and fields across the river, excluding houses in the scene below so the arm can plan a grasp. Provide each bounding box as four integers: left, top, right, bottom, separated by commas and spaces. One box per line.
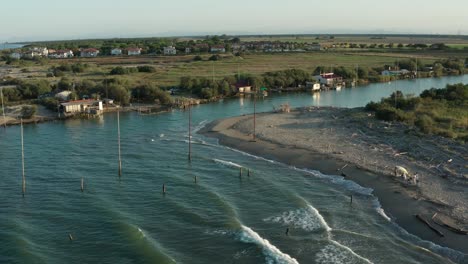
0, 35, 468, 106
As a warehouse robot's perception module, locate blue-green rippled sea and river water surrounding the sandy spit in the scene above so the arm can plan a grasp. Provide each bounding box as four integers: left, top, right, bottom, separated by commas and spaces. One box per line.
0, 75, 468, 263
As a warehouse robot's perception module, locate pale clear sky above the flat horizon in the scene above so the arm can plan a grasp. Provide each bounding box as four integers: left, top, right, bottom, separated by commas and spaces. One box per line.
0, 0, 468, 42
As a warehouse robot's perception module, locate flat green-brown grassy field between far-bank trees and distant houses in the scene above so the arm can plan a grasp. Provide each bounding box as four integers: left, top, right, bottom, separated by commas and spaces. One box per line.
1, 47, 468, 87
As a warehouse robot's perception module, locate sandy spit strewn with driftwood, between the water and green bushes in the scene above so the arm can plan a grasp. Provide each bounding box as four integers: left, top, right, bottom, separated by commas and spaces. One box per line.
200, 107, 468, 254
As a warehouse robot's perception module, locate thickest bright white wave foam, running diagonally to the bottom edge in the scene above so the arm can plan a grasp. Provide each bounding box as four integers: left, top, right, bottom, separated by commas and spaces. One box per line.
239, 225, 299, 264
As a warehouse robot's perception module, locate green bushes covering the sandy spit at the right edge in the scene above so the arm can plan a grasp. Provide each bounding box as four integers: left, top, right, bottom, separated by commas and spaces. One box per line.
366, 84, 468, 142
